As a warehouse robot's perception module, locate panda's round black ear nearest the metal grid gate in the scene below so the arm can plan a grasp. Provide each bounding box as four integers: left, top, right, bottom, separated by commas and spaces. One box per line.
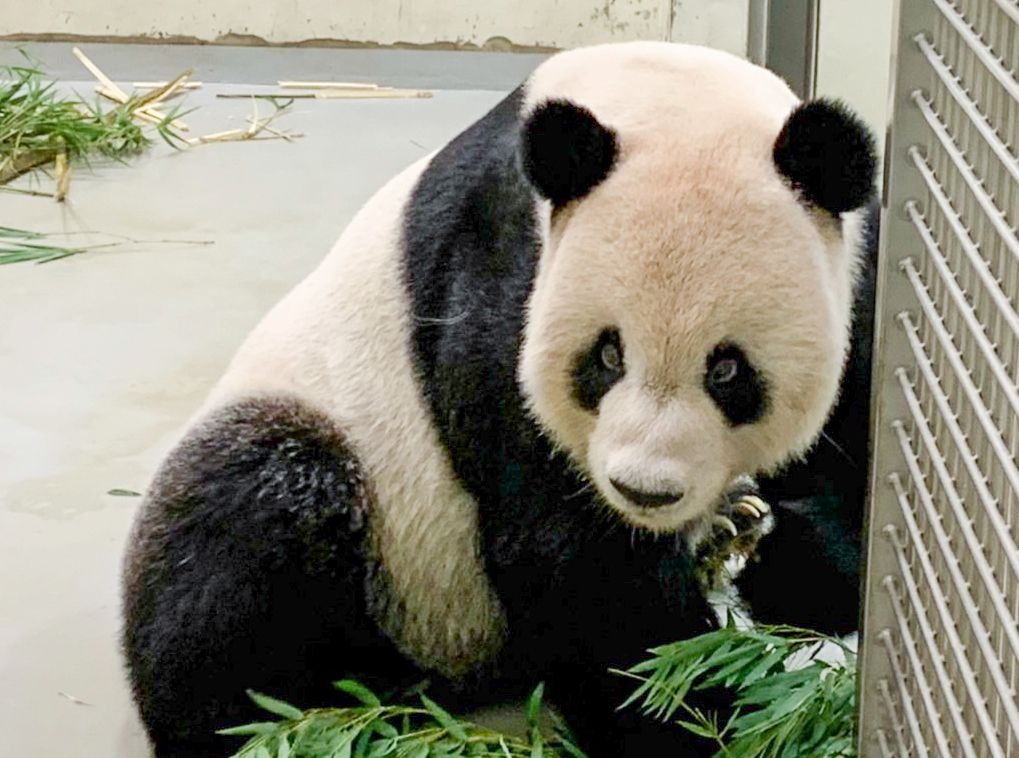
772, 99, 877, 214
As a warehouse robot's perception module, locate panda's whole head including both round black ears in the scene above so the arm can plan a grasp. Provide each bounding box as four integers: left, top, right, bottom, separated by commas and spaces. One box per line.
519, 45, 875, 532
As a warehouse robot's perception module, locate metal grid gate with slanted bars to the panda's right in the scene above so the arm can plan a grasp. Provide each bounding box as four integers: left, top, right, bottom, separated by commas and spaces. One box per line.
860, 0, 1019, 758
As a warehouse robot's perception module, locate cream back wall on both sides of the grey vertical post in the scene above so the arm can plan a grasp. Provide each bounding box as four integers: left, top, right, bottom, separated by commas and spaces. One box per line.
0, 0, 894, 143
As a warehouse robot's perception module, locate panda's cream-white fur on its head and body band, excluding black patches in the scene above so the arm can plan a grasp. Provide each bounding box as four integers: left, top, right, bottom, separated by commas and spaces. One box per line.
196, 42, 858, 675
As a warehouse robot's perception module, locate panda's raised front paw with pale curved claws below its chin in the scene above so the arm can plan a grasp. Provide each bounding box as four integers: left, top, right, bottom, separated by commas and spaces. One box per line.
693, 480, 774, 591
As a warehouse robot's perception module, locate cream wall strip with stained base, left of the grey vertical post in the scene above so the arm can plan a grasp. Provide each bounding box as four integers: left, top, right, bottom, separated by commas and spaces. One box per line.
7, 0, 750, 52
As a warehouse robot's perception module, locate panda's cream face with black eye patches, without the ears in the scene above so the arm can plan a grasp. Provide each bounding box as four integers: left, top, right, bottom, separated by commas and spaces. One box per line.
520, 130, 857, 532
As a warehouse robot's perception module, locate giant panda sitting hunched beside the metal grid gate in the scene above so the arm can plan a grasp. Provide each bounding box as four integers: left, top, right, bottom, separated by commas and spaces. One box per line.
123, 42, 875, 758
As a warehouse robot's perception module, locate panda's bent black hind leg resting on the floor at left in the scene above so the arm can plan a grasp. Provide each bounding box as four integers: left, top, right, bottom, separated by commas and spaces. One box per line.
123, 398, 413, 758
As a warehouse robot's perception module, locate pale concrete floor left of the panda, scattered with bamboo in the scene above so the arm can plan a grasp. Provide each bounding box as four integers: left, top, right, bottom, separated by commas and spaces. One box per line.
0, 44, 538, 758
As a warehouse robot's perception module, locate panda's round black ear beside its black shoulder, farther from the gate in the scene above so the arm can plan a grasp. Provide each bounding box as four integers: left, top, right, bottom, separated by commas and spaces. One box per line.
521, 100, 619, 207
